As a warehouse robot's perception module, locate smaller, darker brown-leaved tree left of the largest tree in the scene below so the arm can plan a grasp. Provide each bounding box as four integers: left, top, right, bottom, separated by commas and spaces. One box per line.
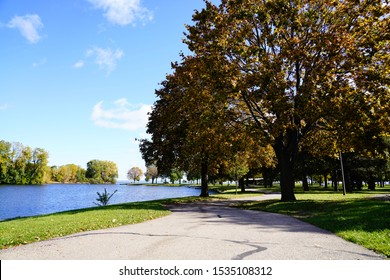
140, 56, 262, 196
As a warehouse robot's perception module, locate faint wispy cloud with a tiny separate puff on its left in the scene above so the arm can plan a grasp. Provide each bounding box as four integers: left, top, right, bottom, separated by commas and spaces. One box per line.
86, 47, 124, 75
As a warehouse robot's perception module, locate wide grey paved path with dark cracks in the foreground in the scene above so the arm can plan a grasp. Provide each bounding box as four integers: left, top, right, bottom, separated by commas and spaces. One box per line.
0, 195, 382, 260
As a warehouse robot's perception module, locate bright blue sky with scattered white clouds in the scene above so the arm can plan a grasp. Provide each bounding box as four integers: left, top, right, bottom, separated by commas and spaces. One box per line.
0, 0, 213, 179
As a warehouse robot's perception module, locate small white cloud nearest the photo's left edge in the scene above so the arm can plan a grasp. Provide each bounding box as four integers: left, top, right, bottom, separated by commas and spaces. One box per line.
7, 15, 43, 44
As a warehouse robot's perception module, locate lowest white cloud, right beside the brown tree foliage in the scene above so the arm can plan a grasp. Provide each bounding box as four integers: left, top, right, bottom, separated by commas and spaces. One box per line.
91, 98, 152, 131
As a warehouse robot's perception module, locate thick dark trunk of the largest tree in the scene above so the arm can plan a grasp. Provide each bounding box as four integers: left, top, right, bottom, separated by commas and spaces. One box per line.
274, 130, 298, 201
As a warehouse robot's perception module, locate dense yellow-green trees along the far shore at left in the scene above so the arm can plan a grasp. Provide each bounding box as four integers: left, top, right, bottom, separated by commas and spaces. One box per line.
0, 140, 118, 185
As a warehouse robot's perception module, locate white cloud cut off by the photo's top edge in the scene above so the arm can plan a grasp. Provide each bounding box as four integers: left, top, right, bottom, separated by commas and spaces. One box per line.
88, 0, 153, 26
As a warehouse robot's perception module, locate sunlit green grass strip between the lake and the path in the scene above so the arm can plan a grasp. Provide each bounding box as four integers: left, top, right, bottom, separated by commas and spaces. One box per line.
0, 201, 170, 249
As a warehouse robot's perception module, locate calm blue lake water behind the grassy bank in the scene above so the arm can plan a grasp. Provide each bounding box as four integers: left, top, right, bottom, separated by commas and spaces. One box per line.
0, 184, 200, 220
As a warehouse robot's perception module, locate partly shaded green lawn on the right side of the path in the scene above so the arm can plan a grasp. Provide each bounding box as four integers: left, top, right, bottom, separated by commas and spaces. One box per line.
240, 193, 390, 258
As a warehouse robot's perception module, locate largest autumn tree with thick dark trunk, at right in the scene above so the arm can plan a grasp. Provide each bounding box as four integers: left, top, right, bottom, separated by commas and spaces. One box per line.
186, 0, 390, 201
